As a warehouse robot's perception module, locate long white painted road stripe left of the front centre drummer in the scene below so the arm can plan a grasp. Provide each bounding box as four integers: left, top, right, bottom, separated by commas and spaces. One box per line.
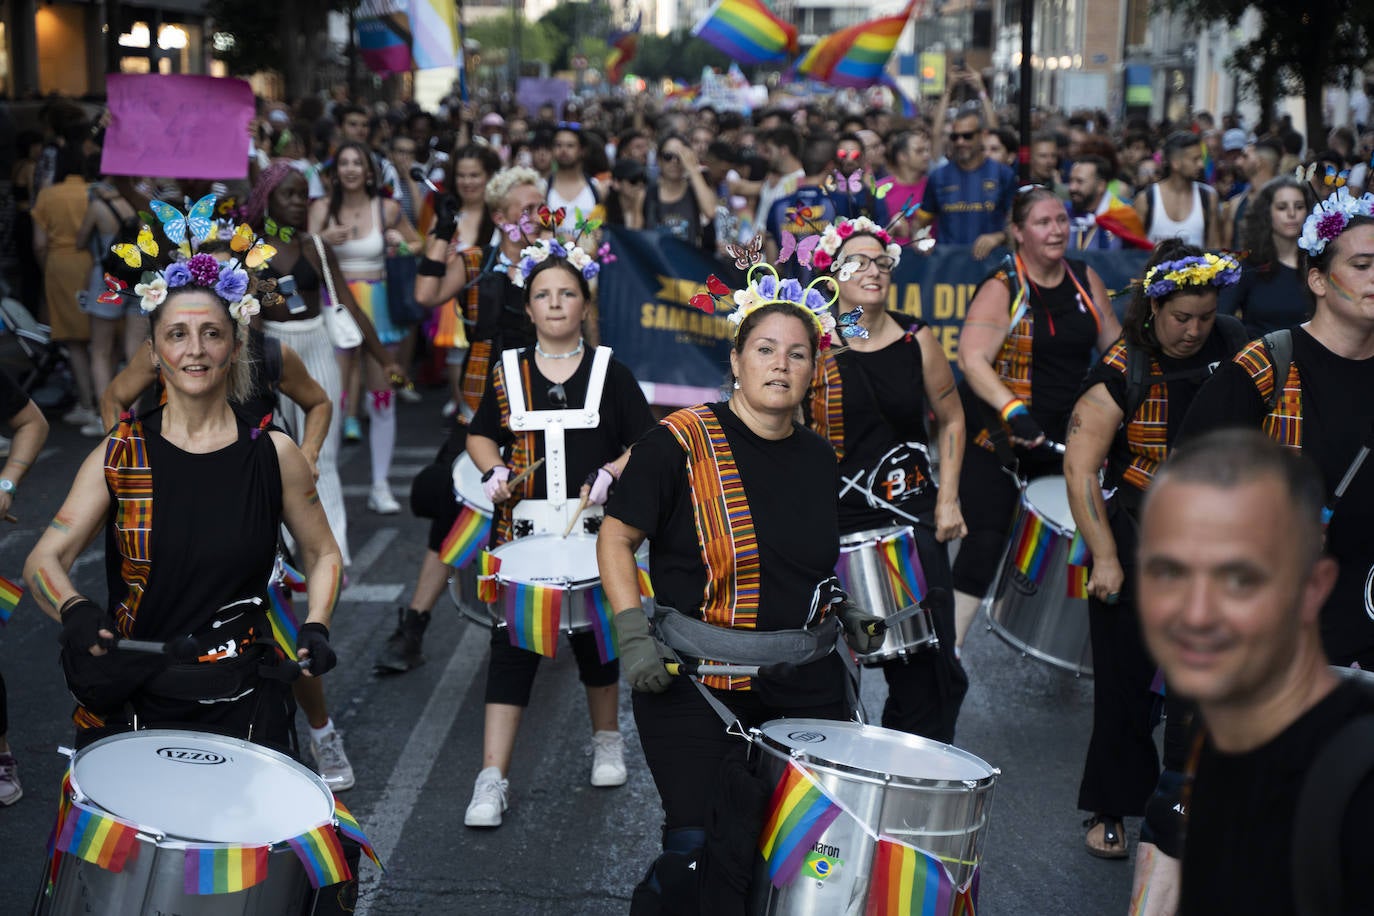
354, 626, 491, 916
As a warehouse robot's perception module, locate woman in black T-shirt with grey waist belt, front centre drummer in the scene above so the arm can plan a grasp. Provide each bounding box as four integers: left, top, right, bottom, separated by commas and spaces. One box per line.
596, 265, 877, 916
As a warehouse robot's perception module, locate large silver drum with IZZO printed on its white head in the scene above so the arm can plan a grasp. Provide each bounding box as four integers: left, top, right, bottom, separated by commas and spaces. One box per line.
38, 729, 334, 916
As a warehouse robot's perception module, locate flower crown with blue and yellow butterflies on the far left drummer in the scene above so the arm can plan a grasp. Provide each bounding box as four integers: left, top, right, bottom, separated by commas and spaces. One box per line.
99, 194, 276, 324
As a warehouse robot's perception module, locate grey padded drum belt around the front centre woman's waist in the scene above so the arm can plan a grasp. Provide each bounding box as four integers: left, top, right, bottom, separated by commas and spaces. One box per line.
651, 575, 868, 743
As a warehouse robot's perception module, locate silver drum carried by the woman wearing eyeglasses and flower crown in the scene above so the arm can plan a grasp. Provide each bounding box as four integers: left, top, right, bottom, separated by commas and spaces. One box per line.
835, 527, 940, 663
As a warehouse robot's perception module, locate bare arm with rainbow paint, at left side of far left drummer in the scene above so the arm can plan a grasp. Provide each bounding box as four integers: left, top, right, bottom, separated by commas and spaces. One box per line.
23, 442, 113, 623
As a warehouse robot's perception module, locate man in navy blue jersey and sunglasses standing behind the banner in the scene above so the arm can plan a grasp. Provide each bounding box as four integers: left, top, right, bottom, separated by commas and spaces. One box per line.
915, 110, 1017, 261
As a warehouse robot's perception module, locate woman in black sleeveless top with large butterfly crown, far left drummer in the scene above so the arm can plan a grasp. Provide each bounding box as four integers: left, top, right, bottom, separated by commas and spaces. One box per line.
25, 216, 344, 755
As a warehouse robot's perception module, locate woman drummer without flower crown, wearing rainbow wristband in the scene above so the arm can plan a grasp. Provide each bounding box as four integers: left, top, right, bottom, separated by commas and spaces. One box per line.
954, 184, 1121, 644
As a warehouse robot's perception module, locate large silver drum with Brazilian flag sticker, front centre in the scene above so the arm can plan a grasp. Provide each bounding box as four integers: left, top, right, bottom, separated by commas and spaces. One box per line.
749, 718, 1000, 916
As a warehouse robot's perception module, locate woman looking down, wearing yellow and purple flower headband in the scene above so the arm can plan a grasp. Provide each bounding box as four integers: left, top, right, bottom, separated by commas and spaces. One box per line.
1063, 239, 1246, 858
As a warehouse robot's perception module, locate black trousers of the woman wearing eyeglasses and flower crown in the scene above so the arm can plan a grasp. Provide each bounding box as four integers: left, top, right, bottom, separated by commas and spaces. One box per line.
881, 526, 969, 744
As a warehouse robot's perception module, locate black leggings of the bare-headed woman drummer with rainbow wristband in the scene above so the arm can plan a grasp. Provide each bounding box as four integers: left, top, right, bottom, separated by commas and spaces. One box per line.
954, 442, 1063, 597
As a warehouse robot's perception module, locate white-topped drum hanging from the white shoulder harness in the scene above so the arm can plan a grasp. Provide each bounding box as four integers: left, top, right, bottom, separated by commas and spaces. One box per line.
492, 534, 605, 633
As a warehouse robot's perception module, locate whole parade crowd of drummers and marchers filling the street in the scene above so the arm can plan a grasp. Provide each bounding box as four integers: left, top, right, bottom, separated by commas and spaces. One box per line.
0, 80, 1374, 915
